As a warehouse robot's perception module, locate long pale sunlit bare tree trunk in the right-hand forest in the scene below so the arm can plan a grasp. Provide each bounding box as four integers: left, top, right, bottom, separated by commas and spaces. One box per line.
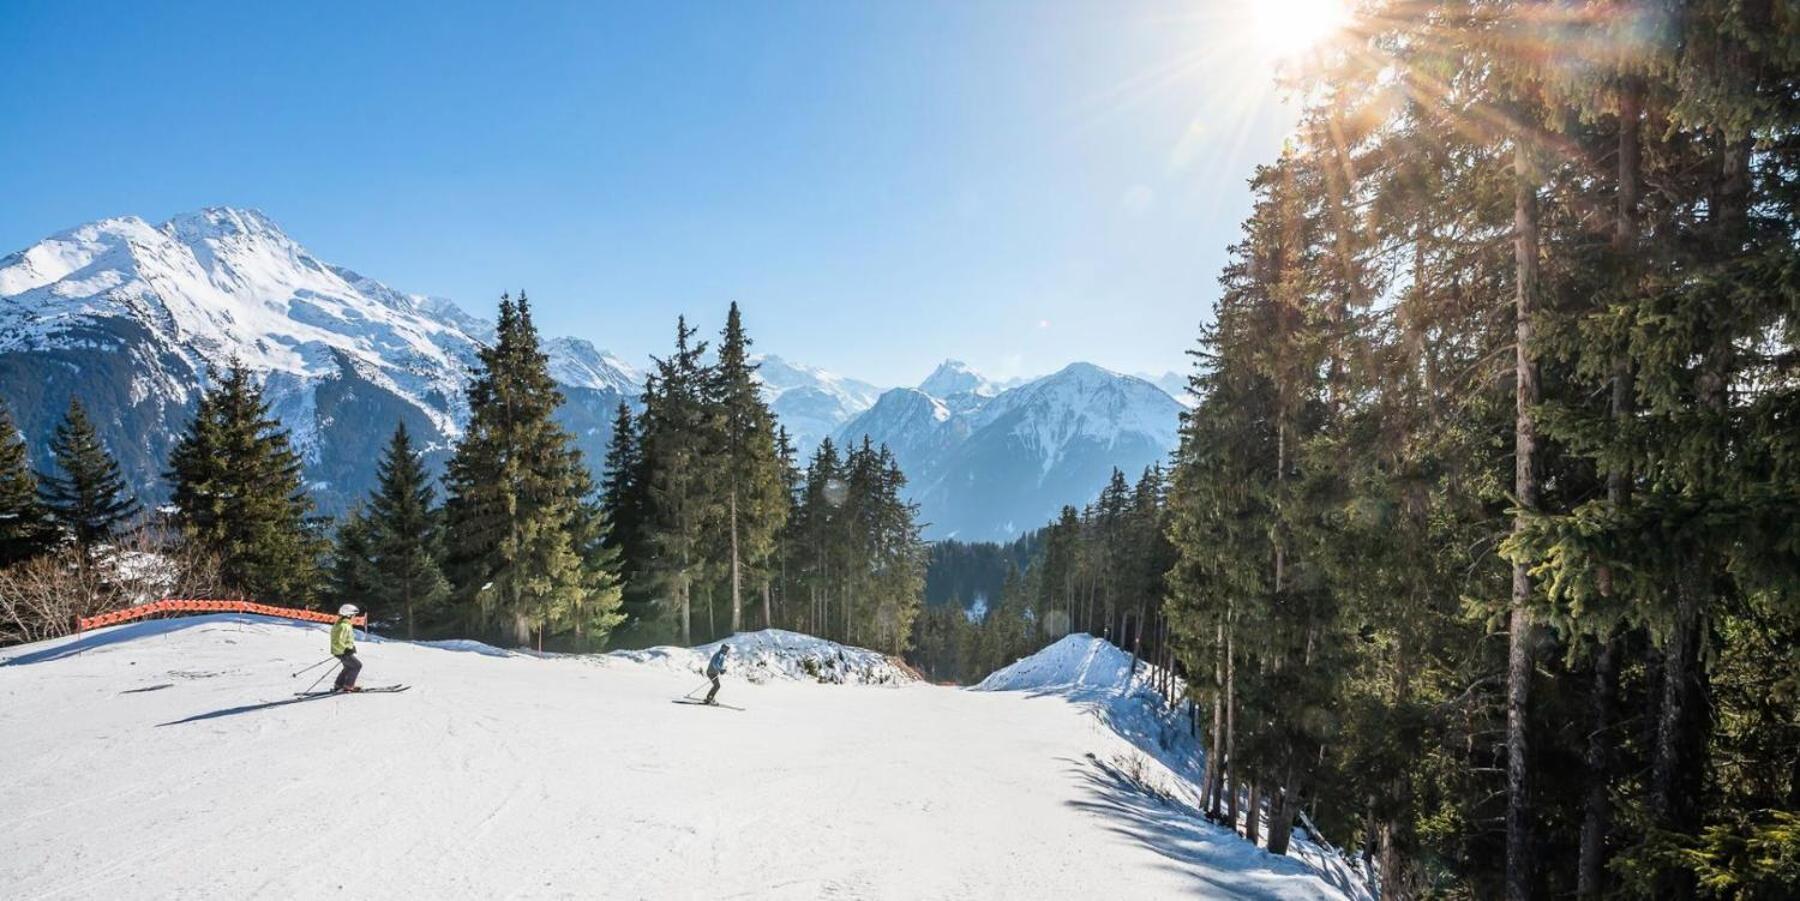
1507, 137, 1539, 901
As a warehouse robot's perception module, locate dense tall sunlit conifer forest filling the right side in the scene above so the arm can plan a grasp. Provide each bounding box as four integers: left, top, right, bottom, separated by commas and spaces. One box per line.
1152, 0, 1800, 897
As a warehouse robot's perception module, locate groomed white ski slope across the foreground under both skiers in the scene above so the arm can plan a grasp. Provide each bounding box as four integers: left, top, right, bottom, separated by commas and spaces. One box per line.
0, 615, 1354, 899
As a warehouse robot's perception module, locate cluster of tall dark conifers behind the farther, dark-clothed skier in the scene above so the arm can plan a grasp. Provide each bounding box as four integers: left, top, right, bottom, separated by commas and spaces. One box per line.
605, 306, 923, 653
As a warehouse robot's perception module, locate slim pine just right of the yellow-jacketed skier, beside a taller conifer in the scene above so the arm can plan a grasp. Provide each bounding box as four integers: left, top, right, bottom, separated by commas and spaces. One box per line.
367, 423, 450, 638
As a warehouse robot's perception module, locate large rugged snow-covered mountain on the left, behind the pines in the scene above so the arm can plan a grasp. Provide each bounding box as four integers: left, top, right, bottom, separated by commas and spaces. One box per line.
0, 207, 643, 511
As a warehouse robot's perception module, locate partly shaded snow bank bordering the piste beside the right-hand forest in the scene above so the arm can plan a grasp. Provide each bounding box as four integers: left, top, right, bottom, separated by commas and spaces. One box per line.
968, 635, 1373, 901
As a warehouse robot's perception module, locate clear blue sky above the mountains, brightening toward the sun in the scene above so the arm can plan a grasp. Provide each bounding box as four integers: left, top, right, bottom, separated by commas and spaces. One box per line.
0, 0, 1294, 385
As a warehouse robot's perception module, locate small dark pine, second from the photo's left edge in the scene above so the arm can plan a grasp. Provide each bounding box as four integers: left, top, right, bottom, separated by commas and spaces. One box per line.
41, 397, 139, 558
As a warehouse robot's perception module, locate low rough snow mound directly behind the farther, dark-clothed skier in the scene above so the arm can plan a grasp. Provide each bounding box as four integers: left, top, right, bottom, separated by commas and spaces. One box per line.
607, 629, 918, 685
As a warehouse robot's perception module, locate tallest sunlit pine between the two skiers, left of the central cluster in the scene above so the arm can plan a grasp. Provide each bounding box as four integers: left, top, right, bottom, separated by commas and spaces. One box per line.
445, 295, 619, 646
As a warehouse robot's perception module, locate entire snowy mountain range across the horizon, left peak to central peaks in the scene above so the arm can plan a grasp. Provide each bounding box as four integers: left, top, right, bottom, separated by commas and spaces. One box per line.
0, 207, 1179, 538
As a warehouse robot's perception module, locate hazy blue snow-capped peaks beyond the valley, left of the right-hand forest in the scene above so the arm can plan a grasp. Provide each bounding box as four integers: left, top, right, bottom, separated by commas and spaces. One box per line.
833, 361, 1181, 541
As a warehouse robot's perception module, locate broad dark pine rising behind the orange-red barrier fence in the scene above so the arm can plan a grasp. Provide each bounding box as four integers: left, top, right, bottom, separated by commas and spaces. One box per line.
169, 361, 322, 604
